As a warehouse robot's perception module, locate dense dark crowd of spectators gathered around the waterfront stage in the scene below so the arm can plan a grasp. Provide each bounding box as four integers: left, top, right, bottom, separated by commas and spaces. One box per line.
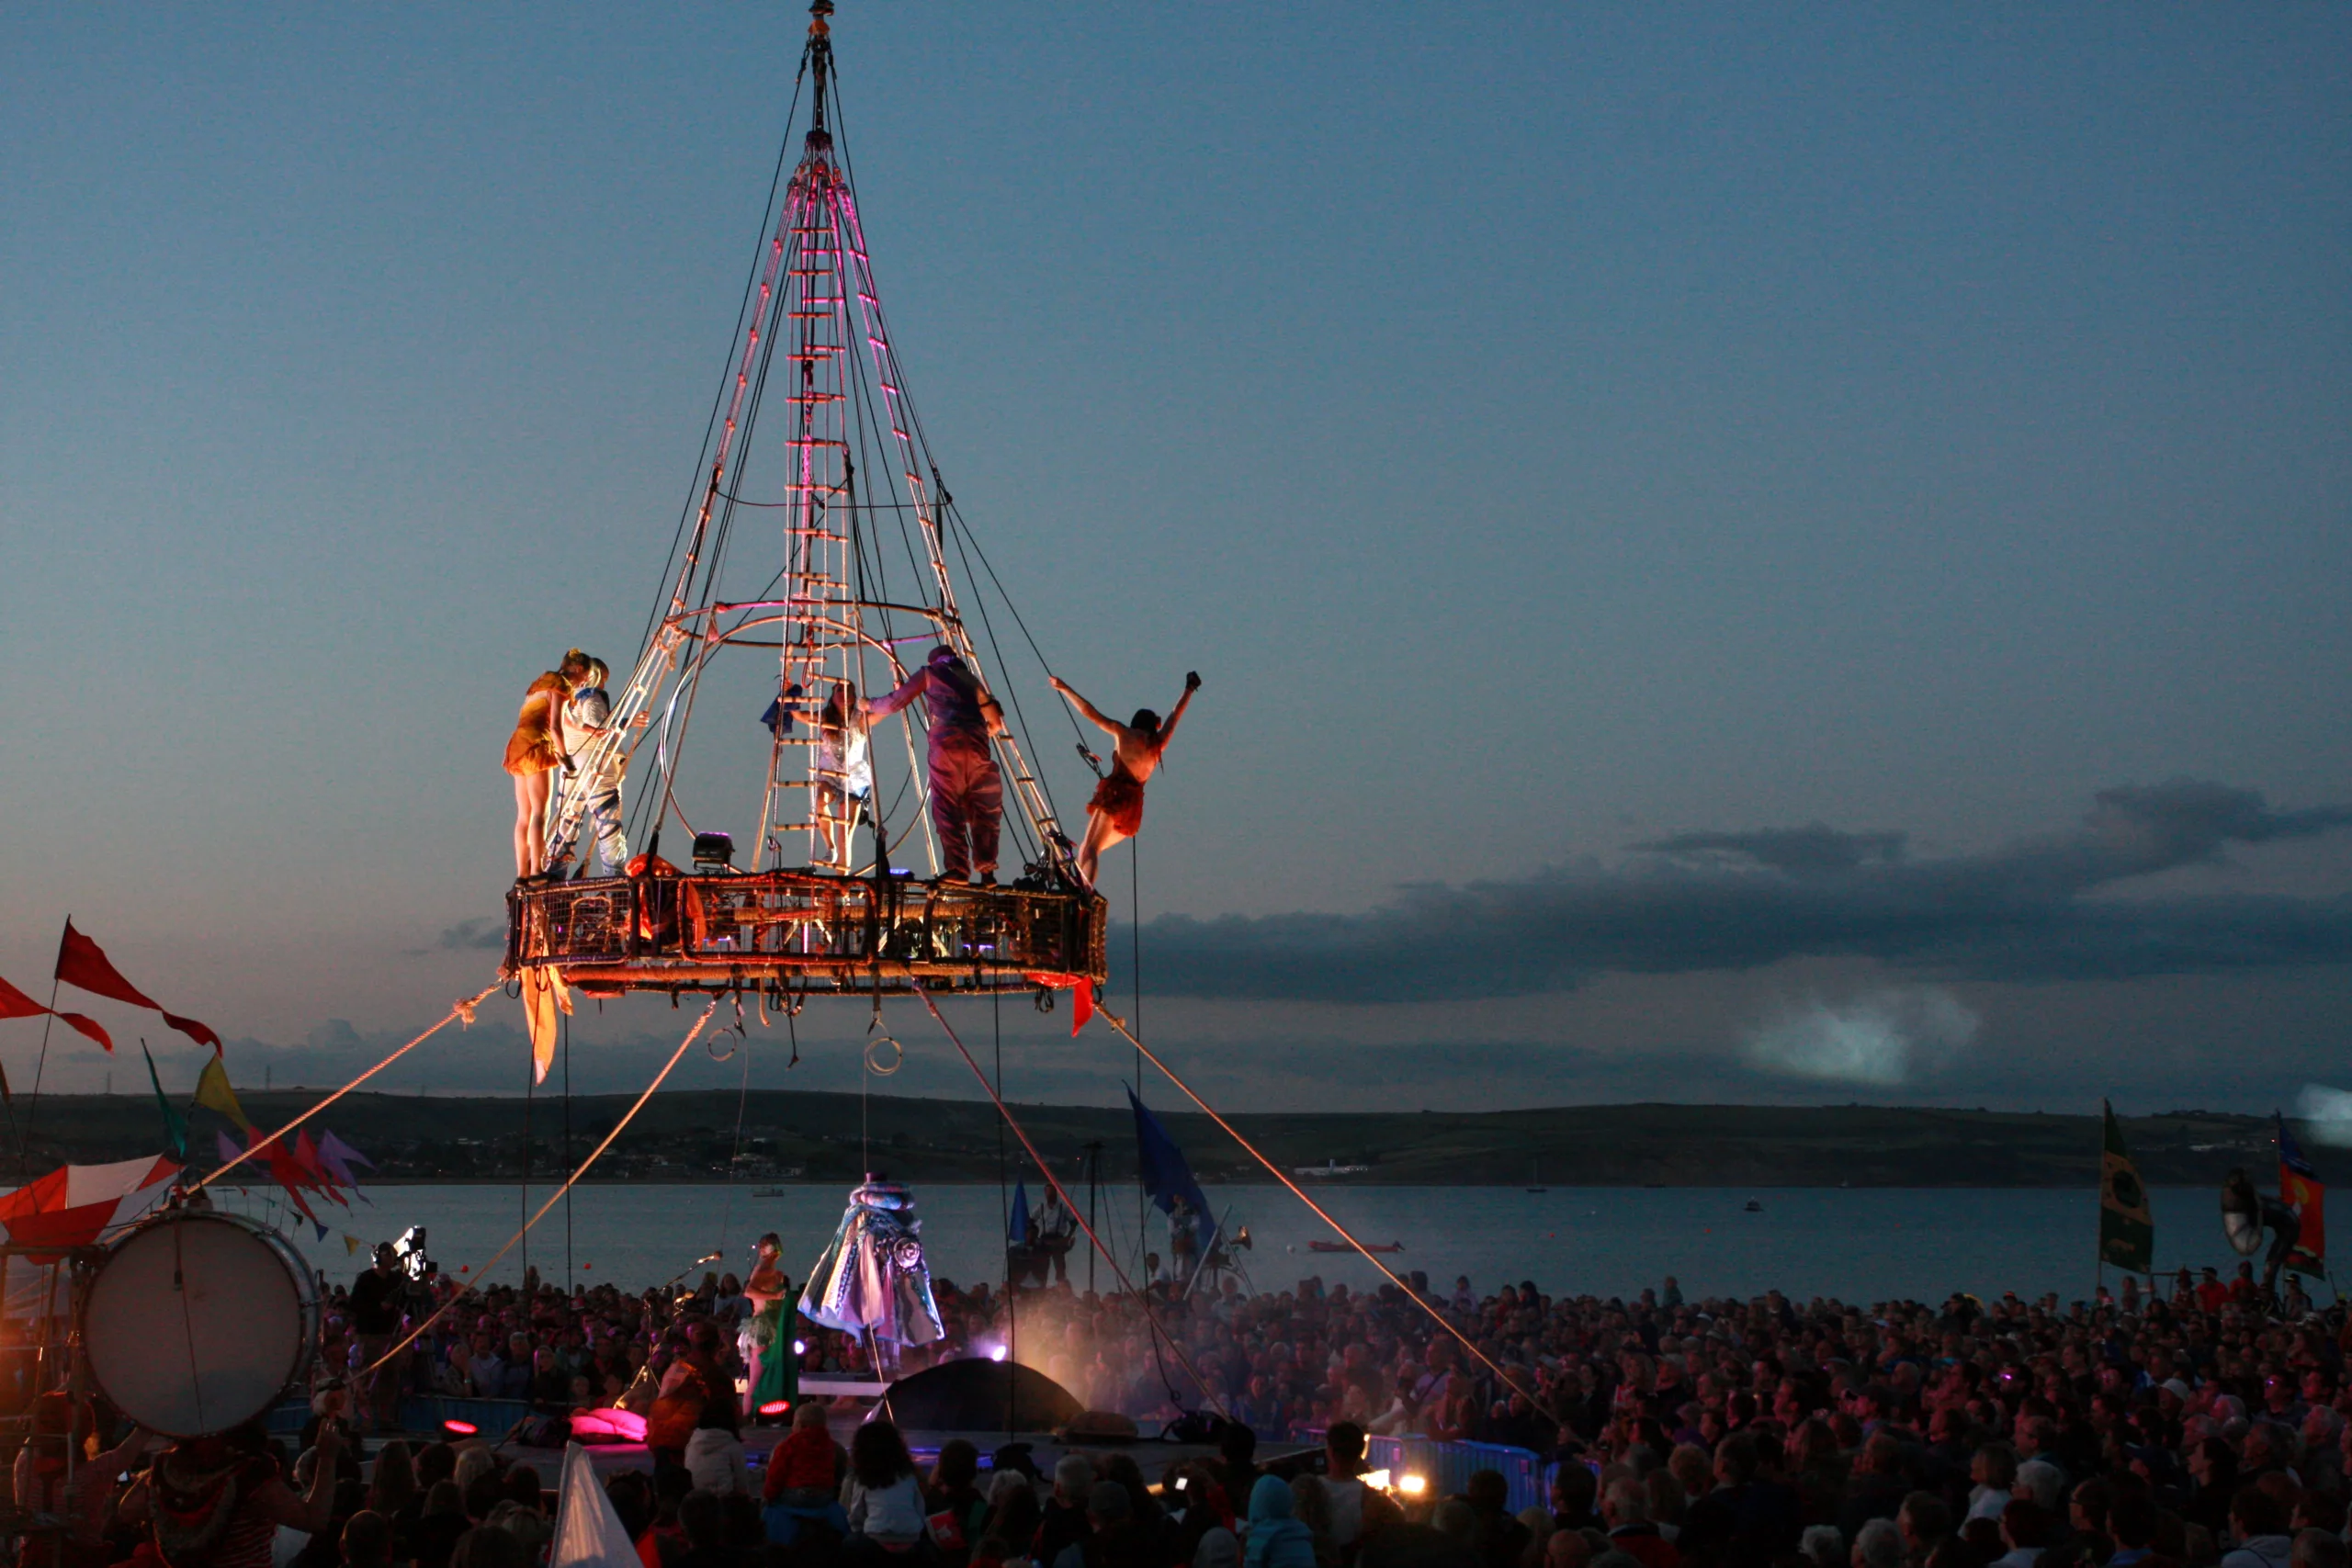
12, 1274, 2352, 1568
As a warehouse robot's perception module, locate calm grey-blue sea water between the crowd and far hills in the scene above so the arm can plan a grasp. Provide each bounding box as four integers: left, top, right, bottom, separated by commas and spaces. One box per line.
243, 1180, 2237, 1303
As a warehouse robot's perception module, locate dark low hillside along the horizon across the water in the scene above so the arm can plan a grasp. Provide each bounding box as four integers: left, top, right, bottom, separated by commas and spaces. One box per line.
5, 1089, 2275, 1187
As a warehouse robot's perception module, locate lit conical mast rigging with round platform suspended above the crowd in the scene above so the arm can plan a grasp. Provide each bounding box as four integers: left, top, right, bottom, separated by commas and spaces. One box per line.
505, 0, 1108, 999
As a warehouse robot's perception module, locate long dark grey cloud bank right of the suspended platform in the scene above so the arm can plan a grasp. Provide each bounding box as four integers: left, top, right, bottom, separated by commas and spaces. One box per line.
1128, 781, 2352, 1001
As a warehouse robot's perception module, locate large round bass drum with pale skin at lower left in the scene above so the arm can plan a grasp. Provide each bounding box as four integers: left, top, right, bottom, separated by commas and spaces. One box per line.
83, 1211, 318, 1437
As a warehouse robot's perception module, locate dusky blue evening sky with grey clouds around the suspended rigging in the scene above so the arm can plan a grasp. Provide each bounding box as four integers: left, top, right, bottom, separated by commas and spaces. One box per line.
0, 0, 2352, 1112
